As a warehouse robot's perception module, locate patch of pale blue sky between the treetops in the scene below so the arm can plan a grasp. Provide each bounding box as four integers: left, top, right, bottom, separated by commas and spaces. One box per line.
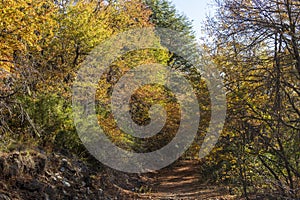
171, 0, 214, 39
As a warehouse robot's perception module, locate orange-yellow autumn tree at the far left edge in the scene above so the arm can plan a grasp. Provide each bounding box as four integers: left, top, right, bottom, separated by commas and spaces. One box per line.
0, 0, 56, 138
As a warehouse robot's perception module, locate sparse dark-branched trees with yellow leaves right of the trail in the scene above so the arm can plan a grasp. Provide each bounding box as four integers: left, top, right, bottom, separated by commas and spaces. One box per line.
208, 0, 300, 198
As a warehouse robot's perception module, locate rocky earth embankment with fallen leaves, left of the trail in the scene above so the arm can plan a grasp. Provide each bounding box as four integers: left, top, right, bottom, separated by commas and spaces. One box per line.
0, 150, 143, 200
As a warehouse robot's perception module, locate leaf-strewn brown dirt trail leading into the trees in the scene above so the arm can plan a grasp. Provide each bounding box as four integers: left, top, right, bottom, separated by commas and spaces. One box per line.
139, 160, 235, 200
